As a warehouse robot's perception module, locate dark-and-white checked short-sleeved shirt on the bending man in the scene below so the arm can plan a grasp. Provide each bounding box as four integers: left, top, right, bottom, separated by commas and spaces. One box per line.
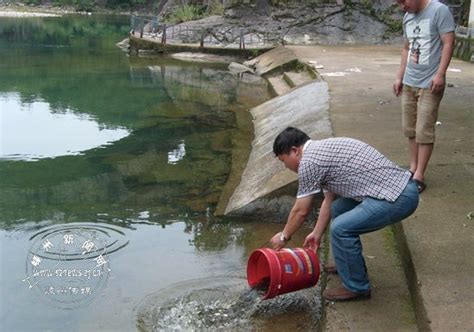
297, 137, 411, 202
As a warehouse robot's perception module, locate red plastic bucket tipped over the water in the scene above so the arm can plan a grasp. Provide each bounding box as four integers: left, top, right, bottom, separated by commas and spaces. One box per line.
247, 248, 319, 299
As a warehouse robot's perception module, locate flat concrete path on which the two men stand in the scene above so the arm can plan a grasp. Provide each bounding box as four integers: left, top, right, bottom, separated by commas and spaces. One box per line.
291, 46, 474, 331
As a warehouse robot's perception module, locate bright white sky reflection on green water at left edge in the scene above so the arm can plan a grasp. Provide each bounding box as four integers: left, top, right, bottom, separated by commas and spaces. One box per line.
0, 93, 130, 161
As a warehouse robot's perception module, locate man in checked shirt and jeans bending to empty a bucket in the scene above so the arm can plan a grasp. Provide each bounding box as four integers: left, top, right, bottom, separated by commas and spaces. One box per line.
270, 127, 418, 301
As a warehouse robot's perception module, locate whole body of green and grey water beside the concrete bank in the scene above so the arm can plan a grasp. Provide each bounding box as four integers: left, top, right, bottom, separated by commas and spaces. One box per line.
0, 15, 319, 331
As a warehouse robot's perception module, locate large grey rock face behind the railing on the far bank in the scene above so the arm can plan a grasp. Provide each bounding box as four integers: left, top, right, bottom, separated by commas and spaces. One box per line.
156, 0, 402, 47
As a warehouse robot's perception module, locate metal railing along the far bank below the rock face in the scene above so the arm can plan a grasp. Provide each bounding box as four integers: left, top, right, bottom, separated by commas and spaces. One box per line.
130, 16, 280, 49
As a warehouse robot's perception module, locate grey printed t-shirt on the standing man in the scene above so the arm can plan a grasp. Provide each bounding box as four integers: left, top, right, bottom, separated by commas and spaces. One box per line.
403, 1, 455, 88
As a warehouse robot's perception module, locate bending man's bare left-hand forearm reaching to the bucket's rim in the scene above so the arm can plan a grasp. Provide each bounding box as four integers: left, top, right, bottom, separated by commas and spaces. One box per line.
270, 195, 313, 250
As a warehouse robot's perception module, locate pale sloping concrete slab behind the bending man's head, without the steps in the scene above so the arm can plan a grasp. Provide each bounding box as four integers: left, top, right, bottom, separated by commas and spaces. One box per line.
224, 81, 332, 215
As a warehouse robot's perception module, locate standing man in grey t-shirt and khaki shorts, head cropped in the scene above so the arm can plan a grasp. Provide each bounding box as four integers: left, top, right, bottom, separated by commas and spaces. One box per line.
393, 0, 455, 193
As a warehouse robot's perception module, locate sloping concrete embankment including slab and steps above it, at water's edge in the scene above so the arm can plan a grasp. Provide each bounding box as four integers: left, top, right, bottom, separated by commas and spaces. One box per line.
217, 47, 332, 216
